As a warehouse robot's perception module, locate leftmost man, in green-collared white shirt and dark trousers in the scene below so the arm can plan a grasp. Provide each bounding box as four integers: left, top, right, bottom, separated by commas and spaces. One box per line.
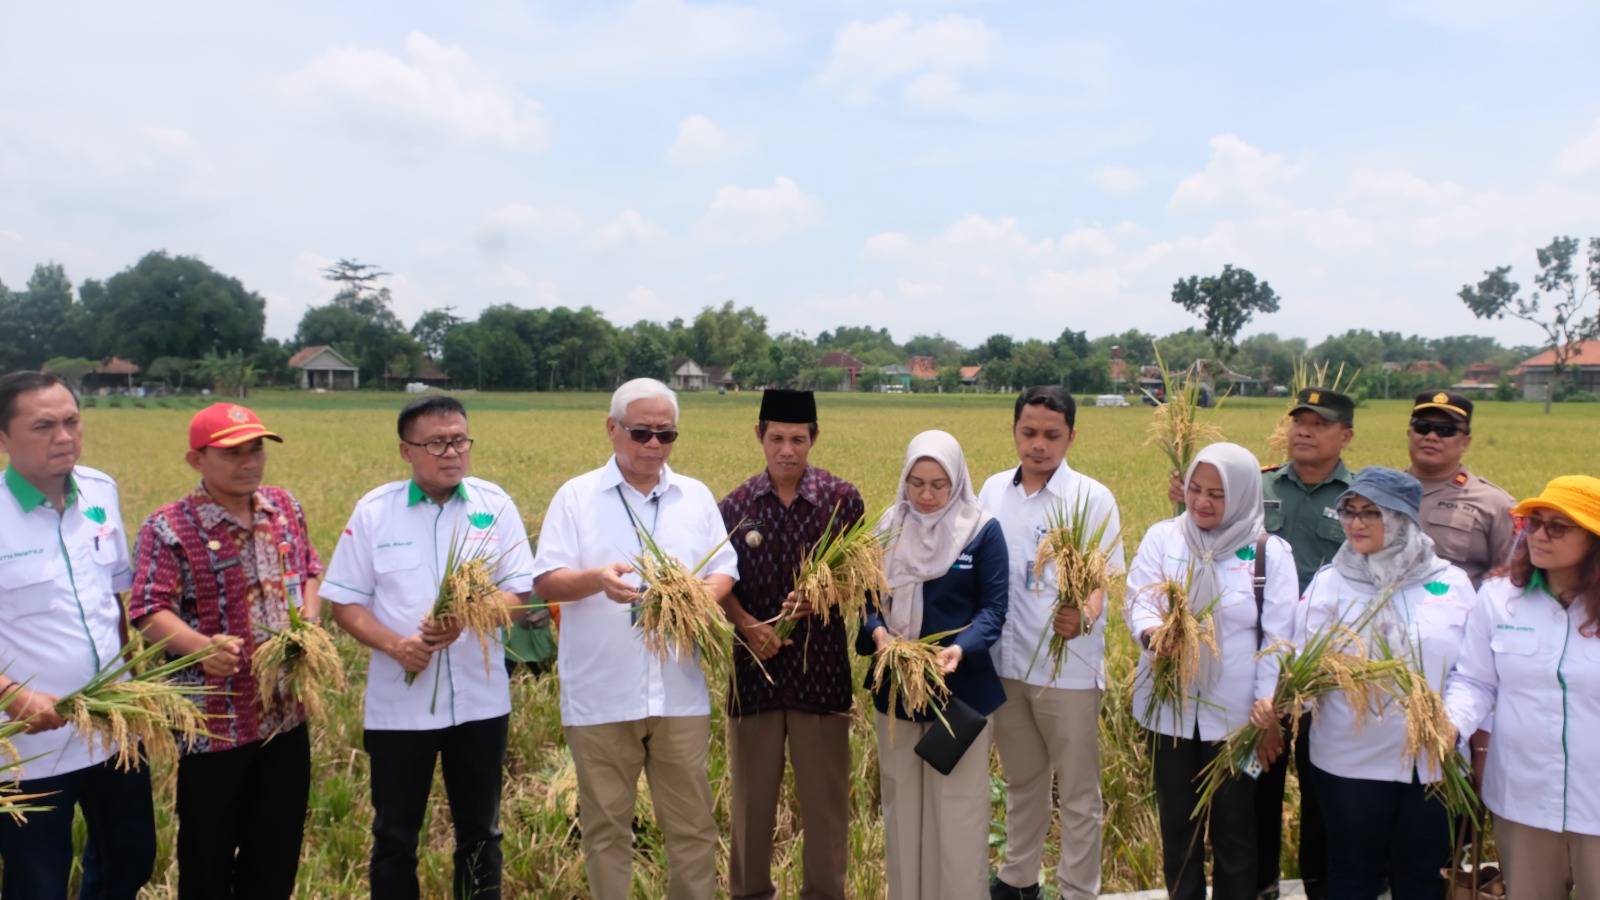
0, 372, 155, 900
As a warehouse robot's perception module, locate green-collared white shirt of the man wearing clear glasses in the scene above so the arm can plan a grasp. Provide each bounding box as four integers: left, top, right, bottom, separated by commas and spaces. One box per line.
320, 477, 533, 732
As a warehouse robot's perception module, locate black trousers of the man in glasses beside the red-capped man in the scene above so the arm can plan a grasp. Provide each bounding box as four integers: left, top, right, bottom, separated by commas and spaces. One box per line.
363, 716, 510, 900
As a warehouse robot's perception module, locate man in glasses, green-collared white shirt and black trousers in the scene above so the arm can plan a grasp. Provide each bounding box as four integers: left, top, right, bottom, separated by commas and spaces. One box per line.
322, 397, 533, 900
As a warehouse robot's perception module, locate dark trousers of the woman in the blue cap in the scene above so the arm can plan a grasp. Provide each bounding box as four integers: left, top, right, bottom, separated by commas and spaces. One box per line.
1312, 759, 1451, 900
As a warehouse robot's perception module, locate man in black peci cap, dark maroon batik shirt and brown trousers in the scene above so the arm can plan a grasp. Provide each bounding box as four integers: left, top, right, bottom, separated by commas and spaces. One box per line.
720, 391, 862, 900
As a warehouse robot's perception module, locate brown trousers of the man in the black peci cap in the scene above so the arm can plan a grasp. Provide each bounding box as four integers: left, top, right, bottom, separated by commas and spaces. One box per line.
728, 709, 850, 900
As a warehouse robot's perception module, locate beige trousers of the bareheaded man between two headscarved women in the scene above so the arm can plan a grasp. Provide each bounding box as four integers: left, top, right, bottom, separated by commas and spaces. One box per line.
994, 677, 1102, 900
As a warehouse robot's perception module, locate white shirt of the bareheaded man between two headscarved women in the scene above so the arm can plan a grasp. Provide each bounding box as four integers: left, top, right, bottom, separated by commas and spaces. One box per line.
978, 460, 1126, 690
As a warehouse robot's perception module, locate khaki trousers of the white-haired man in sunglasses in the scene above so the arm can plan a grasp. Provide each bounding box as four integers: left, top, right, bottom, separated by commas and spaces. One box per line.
566, 716, 717, 900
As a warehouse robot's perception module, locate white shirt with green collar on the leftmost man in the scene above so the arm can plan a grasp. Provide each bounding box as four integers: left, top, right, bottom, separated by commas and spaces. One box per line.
0, 466, 133, 778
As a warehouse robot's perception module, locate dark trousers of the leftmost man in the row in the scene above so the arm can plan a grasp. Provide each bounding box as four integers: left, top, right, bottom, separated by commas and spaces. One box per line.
0, 759, 155, 900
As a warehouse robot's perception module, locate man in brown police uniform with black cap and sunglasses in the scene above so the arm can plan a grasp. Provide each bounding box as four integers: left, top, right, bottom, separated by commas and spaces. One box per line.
1406, 391, 1514, 588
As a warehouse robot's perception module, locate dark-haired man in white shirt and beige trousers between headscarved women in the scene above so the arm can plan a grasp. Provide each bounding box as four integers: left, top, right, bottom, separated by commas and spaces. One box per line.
978, 386, 1125, 900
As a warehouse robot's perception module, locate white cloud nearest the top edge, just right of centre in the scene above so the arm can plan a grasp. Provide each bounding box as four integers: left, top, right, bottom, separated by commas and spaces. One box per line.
816, 11, 1000, 109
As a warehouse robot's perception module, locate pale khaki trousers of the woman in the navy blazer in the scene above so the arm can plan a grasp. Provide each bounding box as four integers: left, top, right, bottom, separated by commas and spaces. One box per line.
875, 713, 994, 900
